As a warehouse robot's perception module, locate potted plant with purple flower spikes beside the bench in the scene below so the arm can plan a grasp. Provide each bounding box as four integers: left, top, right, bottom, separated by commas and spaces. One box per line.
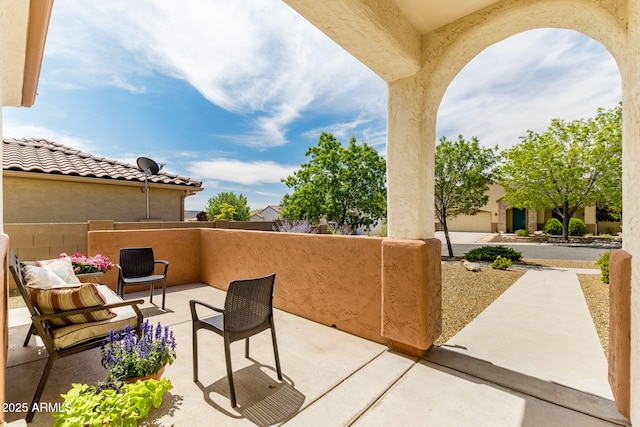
101, 320, 176, 381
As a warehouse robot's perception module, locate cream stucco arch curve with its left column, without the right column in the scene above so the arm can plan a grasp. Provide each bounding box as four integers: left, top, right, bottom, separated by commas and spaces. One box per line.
387, 0, 627, 239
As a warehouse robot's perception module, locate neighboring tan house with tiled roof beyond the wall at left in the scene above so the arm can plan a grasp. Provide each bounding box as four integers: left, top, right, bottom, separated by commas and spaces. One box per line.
2, 138, 203, 223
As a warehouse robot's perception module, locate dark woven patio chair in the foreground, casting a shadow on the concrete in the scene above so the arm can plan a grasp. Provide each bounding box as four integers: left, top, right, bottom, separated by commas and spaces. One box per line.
189, 273, 282, 408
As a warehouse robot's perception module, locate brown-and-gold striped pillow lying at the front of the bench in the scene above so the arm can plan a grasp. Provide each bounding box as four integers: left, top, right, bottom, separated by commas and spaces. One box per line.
27, 283, 116, 326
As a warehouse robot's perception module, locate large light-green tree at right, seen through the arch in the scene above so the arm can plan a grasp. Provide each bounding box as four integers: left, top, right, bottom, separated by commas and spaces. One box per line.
500, 105, 622, 240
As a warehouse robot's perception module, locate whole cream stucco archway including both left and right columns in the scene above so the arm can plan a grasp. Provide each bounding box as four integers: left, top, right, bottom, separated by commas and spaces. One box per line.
387, 0, 640, 422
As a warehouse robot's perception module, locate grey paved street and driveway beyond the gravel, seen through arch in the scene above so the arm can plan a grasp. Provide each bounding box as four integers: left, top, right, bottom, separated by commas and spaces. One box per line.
436, 232, 617, 261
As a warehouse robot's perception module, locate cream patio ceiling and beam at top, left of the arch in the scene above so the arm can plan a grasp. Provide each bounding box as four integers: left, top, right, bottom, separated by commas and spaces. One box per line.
284, 0, 498, 82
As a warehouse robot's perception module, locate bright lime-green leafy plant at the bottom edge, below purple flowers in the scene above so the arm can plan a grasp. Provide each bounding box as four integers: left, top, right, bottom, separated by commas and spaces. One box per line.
52, 378, 173, 427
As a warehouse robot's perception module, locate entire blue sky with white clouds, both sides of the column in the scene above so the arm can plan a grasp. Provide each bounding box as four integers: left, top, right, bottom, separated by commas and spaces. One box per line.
3, 0, 621, 210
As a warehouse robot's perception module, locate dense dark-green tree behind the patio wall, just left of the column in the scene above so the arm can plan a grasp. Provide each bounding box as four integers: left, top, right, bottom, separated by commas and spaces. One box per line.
281, 132, 387, 234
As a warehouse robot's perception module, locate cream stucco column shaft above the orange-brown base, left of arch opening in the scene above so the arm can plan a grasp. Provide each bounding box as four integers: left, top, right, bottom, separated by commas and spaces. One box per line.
387, 74, 436, 239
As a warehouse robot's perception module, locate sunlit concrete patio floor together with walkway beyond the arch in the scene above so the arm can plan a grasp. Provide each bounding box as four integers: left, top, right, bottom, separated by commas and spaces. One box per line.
5, 269, 628, 426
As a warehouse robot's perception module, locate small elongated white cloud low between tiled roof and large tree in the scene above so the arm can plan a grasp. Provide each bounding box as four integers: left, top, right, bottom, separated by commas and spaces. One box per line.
187, 159, 298, 185
